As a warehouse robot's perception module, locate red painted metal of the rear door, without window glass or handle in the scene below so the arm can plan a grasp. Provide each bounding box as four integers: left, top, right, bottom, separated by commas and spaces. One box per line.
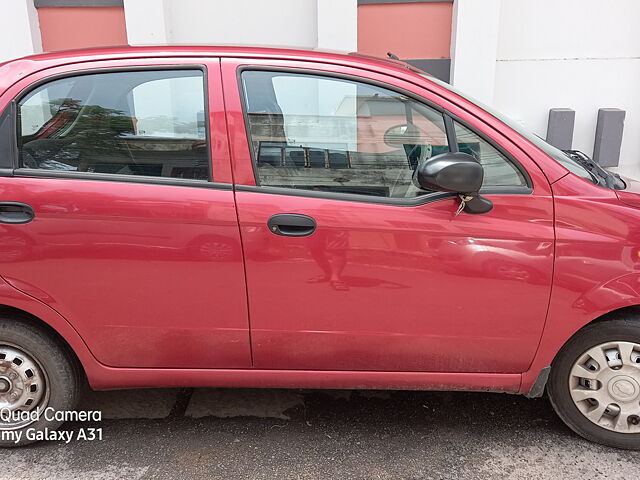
0, 58, 251, 368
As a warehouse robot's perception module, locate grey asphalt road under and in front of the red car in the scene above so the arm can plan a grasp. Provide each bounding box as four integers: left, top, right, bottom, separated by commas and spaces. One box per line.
0, 389, 640, 480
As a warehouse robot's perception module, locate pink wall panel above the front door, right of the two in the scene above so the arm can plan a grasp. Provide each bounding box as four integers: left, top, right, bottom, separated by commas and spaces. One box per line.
358, 2, 453, 59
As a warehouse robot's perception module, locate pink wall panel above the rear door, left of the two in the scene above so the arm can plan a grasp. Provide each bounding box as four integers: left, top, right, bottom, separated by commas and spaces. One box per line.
38, 7, 127, 52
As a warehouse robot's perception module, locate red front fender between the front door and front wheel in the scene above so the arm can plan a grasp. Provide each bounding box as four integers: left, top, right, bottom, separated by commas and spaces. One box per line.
521, 175, 640, 392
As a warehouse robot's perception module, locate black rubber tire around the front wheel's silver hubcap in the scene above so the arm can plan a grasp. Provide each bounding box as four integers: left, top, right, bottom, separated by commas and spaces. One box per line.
547, 315, 640, 450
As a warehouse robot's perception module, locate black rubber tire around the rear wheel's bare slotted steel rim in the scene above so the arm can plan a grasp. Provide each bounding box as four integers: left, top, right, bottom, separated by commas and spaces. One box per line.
0, 316, 83, 447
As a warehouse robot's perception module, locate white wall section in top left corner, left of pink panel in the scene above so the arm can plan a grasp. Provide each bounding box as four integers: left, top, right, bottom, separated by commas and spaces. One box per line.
0, 0, 42, 63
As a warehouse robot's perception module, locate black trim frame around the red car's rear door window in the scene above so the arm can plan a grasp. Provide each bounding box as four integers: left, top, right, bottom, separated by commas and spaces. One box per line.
9, 57, 220, 189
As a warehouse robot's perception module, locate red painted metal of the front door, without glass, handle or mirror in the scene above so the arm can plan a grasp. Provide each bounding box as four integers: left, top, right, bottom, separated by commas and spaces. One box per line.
222, 59, 553, 373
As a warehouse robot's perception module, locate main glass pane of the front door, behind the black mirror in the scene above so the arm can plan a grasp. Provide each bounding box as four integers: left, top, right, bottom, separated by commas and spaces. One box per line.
242, 71, 449, 198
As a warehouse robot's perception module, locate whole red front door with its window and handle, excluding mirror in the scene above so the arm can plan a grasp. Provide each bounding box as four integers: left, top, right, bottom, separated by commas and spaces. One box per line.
223, 60, 553, 373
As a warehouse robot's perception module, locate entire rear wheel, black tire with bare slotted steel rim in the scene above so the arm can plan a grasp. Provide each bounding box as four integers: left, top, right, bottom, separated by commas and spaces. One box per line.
0, 317, 80, 447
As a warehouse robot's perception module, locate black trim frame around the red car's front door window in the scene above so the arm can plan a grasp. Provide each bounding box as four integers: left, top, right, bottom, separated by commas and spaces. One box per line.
235, 64, 533, 207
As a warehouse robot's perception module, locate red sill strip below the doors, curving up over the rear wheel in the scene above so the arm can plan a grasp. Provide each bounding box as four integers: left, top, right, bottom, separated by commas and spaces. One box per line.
0, 278, 521, 393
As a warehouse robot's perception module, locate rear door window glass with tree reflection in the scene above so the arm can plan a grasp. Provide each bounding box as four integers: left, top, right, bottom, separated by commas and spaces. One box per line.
18, 70, 210, 180
